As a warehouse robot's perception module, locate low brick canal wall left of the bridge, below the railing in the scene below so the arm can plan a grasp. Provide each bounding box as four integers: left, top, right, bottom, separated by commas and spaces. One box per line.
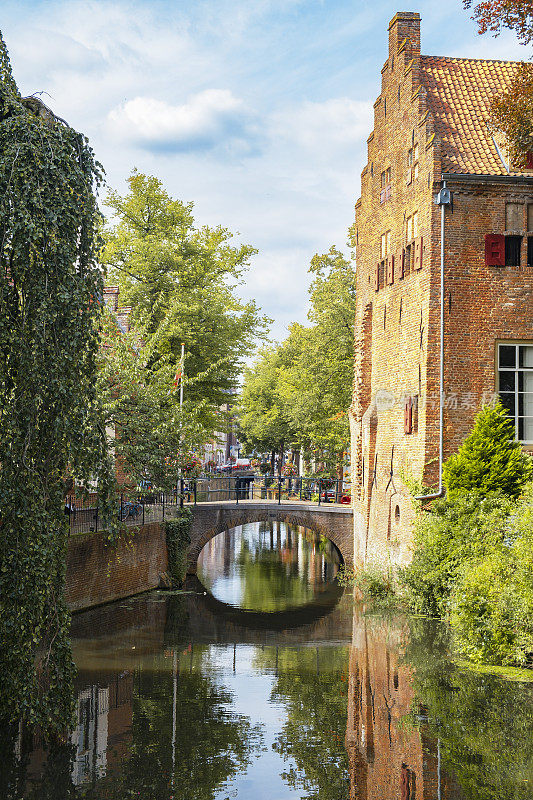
66, 522, 167, 611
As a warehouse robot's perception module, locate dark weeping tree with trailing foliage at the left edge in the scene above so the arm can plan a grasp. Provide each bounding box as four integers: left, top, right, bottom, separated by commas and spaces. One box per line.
0, 29, 110, 732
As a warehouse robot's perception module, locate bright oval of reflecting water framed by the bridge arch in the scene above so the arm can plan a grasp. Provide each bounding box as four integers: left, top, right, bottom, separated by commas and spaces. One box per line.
198, 522, 340, 612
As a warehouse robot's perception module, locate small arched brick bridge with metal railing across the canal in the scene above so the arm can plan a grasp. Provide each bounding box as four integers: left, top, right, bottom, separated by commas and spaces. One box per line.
187, 500, 353, 575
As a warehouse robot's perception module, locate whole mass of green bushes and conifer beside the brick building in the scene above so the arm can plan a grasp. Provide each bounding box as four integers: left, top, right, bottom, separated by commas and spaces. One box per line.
399, 405, 533, 665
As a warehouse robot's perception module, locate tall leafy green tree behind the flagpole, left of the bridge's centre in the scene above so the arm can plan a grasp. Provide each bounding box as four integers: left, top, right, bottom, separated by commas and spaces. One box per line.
103, 171, 267, 431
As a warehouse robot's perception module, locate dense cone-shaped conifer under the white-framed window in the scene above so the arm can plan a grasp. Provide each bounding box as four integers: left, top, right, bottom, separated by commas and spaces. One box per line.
442, 403, 533, 499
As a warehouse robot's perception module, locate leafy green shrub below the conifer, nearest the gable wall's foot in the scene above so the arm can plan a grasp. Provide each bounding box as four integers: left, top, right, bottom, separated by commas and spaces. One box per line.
398, 492, 513, 616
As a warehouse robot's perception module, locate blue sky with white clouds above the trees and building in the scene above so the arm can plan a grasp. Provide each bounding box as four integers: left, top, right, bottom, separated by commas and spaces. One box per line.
0, 0, 529, 340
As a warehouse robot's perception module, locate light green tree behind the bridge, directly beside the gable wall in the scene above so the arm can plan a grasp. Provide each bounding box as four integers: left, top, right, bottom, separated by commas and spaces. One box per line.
241, 247, 355, 469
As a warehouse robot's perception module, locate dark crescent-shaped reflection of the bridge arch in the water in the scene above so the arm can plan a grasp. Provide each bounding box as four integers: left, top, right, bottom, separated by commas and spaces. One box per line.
185, 575, 344, 631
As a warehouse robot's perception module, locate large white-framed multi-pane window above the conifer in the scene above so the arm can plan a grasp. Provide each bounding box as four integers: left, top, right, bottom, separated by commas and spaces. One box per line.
498, 342, 533, 444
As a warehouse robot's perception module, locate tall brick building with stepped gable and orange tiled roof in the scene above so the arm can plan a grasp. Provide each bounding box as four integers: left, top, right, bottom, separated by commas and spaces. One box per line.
350, 12, 533, 563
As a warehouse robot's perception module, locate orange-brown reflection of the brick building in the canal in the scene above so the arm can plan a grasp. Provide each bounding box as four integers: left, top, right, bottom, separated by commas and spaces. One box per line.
346, 621, 462, 800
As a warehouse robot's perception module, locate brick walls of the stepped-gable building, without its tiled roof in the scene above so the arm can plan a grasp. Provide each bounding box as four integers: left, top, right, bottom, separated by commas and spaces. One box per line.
350, 12, 533, 564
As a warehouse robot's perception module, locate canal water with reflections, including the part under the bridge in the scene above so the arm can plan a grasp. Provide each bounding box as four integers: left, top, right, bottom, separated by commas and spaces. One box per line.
4, 523, 533, 800
